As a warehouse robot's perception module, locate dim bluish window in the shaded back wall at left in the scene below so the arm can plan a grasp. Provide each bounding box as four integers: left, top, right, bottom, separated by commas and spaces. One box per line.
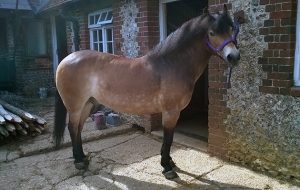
26, 20, 47, 56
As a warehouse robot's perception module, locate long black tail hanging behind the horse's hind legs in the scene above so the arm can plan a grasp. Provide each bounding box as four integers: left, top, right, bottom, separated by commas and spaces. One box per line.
53, 91, 67, 149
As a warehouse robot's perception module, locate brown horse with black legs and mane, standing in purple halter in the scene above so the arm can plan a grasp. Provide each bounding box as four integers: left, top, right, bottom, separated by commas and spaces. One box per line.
54, 6, 240, 179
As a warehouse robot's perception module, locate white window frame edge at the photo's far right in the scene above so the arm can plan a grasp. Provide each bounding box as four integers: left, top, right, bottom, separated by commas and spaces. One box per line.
294, 0, 300, 86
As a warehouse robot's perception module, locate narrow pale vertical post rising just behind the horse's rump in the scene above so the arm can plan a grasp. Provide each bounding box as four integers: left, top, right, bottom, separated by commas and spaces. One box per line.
50, 15, 58, 75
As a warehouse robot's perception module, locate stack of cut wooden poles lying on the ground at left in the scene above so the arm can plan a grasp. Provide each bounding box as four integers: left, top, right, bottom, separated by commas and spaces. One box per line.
0, 100, 47, 140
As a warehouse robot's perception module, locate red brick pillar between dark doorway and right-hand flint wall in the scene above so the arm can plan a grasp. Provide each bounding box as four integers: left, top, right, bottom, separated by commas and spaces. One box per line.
208, 0, 231, 159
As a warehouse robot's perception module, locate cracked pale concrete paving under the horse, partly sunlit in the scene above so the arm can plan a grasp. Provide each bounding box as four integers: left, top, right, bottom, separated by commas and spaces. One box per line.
0, 126, 300, 190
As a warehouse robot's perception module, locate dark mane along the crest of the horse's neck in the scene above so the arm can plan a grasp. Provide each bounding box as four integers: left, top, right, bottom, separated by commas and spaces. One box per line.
147, 14, 213, 57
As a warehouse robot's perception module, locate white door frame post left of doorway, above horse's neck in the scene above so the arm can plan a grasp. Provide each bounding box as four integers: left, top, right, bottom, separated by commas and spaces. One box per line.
159, 0, 179, 41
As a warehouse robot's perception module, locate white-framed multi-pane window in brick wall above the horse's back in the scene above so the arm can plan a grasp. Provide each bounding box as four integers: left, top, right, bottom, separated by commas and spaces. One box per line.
89, 9, 114, 53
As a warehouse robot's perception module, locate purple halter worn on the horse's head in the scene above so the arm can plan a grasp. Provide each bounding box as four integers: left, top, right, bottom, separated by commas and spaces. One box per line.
206, 19, 240, 53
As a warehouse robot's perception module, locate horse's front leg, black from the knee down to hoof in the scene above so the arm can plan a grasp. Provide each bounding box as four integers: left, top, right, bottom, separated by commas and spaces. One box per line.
161, 111, 180, 179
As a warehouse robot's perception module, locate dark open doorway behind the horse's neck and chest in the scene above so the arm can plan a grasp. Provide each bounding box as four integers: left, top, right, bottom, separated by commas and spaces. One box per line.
166, 0, 208, 141
